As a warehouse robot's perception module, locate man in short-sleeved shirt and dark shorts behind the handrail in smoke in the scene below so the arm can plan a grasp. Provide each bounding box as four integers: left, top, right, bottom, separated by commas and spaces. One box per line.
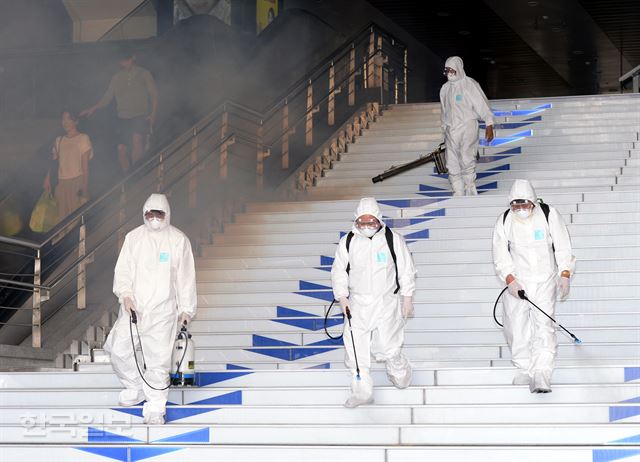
80, 52, 158, 172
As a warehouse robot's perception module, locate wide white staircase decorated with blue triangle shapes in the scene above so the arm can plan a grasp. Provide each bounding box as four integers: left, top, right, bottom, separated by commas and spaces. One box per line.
0, 96, 640, 462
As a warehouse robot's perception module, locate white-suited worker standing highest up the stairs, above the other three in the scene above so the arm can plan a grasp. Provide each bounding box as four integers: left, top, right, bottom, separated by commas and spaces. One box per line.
440, 56, 493, 196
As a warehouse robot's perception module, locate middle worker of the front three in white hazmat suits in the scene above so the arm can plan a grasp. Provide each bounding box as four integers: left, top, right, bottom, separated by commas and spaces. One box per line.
331, 197, 416, 407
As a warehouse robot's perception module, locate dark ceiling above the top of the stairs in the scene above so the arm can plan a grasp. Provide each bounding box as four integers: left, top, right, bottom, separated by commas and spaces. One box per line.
369, 0, 640, 98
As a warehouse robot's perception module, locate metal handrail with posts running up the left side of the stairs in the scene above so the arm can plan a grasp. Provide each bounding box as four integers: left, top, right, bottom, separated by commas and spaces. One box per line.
0, 20, 408, 346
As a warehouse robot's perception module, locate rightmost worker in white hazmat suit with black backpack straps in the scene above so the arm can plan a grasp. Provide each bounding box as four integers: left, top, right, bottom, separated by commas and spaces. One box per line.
493, 180, 575, 393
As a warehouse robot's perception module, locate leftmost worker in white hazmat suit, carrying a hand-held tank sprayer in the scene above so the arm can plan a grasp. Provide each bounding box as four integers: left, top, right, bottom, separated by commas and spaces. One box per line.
105, 194, 196, 424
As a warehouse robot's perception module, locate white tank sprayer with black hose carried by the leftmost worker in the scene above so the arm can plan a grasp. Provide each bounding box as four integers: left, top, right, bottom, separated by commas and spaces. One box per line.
129, 311, 196, 391
